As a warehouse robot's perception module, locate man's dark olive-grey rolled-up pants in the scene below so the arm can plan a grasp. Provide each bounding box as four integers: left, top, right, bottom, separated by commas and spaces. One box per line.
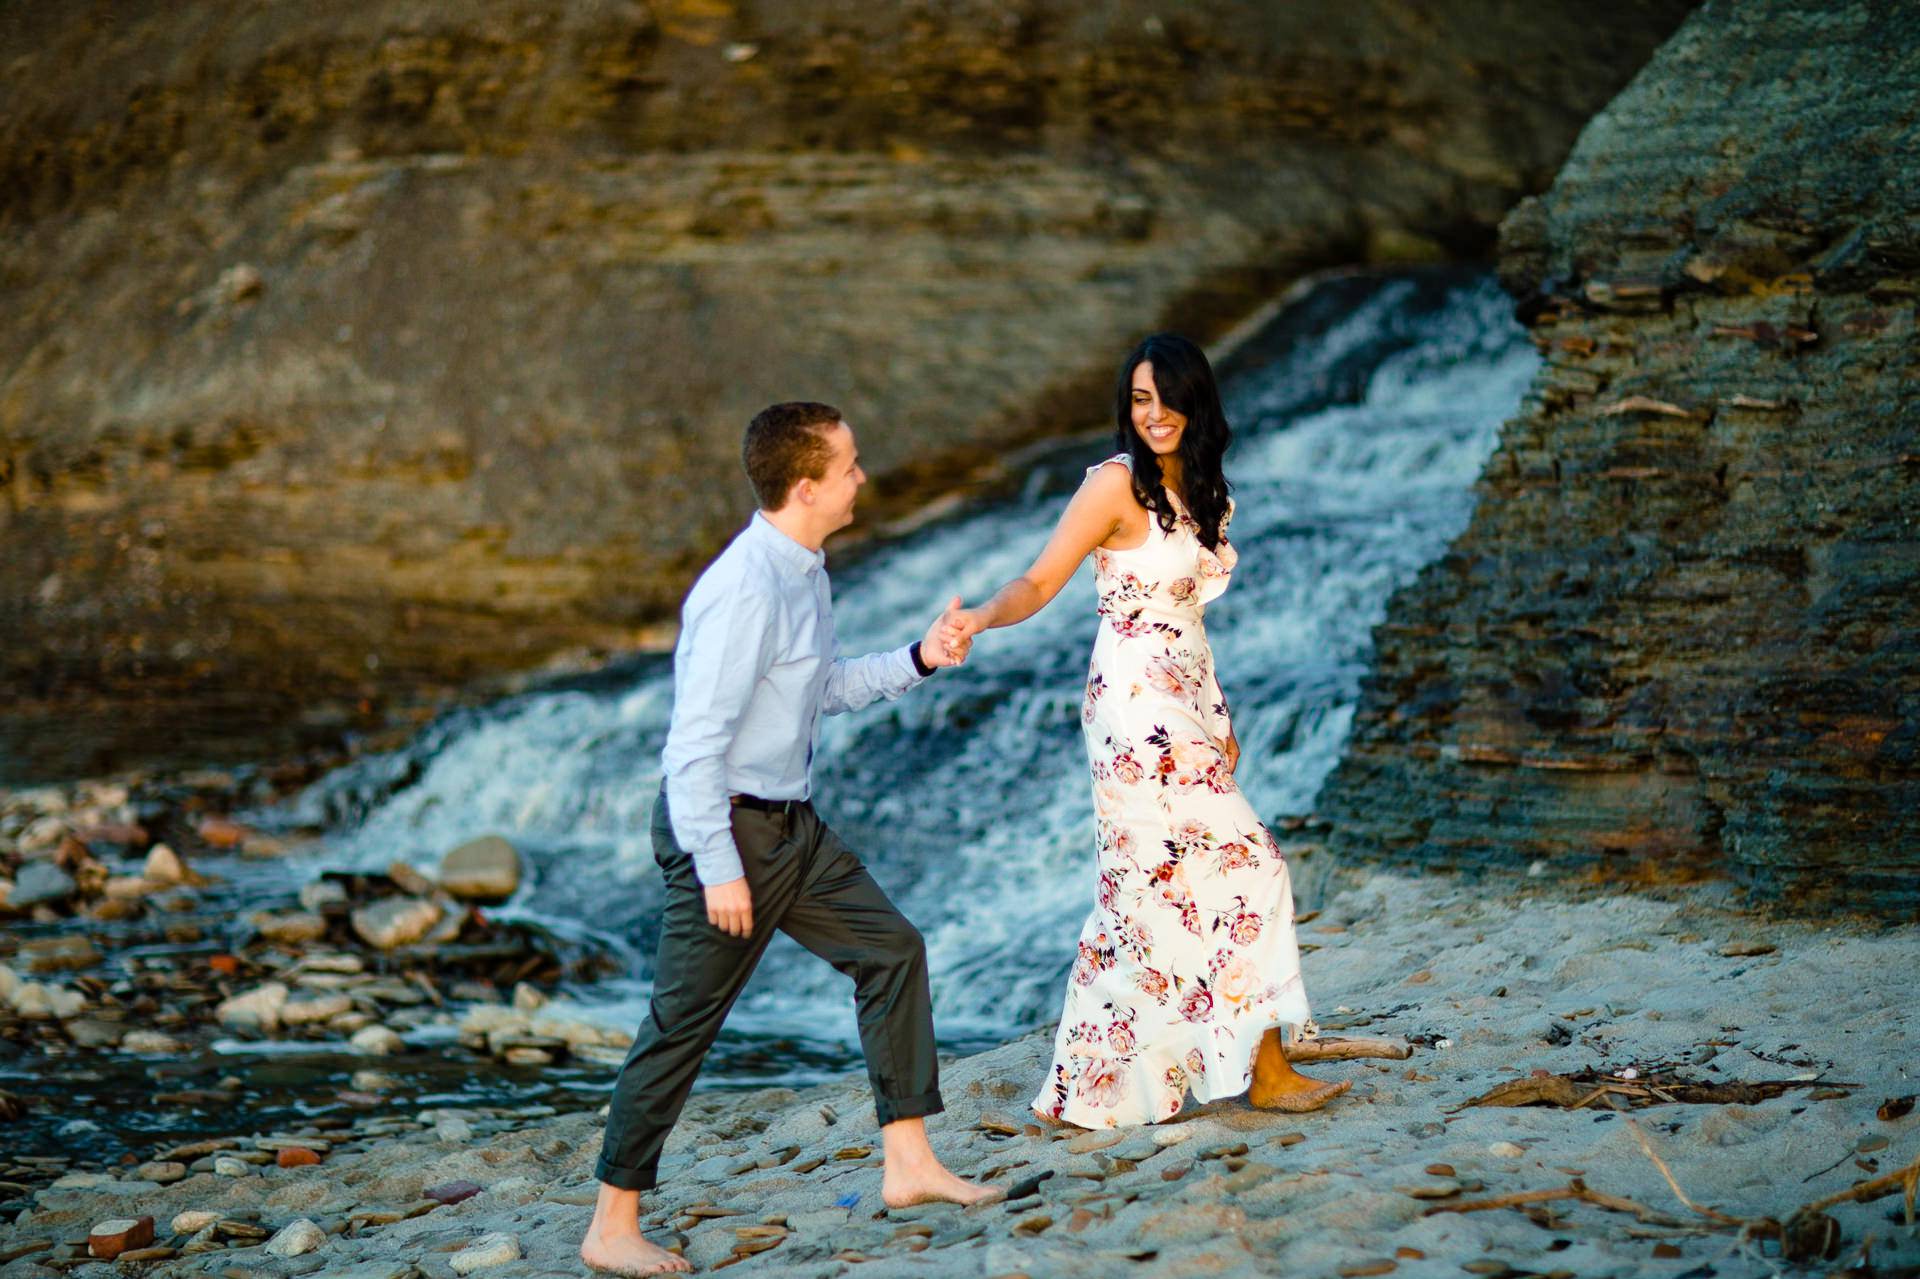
595, 795, 941, 1191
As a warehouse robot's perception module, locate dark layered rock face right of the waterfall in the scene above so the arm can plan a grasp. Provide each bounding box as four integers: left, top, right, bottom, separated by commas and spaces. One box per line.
1321, 0, 1920, 916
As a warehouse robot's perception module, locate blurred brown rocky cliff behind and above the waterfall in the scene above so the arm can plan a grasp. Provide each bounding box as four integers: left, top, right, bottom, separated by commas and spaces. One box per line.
0, 0, 1688, 774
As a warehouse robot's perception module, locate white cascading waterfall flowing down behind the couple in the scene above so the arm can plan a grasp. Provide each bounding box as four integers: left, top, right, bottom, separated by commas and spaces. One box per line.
284, 271, 1538, 1085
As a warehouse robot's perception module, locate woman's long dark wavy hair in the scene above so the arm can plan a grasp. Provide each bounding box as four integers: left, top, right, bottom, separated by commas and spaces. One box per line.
1114, 332, 1233, 551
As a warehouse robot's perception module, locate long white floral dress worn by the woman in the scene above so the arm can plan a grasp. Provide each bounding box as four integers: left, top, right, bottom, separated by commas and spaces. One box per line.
1033, 455, 1309, 1127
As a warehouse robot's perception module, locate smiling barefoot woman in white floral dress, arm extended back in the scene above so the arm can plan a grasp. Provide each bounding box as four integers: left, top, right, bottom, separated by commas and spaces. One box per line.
948, 334, 1350, 1127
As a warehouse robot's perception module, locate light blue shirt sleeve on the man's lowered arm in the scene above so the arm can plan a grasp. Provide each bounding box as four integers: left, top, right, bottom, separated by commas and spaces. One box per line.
660, 582, 776, 885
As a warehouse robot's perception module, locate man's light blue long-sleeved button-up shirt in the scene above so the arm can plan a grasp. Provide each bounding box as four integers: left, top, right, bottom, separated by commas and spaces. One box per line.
660, 513, 924, 883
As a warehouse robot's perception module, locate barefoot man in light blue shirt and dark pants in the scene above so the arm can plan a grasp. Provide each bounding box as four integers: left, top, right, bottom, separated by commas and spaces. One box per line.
580, 403, 998, 1275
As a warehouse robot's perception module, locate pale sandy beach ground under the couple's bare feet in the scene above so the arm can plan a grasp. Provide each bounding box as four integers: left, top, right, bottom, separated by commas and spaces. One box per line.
0, 874, 1920, 1279
